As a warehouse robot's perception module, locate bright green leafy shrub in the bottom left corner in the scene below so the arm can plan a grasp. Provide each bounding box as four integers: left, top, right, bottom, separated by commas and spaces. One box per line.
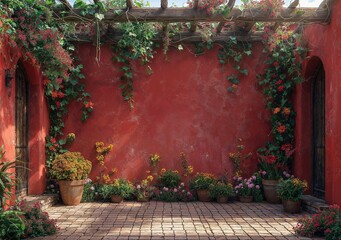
0, 209, 25, 240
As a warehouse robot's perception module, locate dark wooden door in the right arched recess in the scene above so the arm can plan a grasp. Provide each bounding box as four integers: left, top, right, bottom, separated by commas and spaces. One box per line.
312, 63, 325, 199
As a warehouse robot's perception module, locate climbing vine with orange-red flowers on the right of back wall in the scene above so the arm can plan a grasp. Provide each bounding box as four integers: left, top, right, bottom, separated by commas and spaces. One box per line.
258, 26, 306, 176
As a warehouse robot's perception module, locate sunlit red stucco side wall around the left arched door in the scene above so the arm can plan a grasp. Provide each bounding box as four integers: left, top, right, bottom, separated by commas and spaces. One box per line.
0, 36, 49, 202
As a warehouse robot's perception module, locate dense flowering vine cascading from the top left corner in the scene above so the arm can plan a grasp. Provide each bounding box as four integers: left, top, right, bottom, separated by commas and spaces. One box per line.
0, 0, 93, 166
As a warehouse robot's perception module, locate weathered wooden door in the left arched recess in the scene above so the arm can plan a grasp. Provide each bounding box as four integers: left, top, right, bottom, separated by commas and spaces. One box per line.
15, 64, 29, 199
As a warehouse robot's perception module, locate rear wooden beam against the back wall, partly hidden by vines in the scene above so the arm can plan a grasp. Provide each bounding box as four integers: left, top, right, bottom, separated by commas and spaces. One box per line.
67, 30, 264, 43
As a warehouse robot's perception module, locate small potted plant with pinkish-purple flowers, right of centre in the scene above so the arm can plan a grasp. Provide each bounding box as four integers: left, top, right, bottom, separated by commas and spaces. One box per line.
234, 175, 260, 202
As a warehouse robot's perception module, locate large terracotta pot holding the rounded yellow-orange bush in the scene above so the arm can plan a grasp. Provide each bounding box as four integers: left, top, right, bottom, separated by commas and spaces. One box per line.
58, 180, 85, 206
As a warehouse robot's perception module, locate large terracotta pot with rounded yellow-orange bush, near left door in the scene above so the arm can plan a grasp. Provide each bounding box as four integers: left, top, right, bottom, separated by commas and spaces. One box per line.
50, 152, 92, 205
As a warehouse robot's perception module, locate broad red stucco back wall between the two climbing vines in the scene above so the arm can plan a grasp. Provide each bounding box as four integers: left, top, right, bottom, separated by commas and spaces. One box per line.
66, 44, 270, 180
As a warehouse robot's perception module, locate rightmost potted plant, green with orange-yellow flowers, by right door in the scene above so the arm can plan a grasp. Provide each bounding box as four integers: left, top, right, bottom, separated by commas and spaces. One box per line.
277, 178, 308, 213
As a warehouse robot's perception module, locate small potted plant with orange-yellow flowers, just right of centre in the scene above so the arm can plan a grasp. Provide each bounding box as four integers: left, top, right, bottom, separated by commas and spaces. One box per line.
189, 173, 217, 202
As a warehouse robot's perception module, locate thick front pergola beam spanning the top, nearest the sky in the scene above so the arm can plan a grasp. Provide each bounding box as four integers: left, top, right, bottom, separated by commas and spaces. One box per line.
60, 8, 330, 23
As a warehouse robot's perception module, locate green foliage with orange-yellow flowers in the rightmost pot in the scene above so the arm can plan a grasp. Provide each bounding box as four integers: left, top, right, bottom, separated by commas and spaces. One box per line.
277, 178, 308, 201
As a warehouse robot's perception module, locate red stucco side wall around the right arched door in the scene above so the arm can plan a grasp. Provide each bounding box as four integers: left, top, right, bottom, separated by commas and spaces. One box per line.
295, 1, 341, 205
